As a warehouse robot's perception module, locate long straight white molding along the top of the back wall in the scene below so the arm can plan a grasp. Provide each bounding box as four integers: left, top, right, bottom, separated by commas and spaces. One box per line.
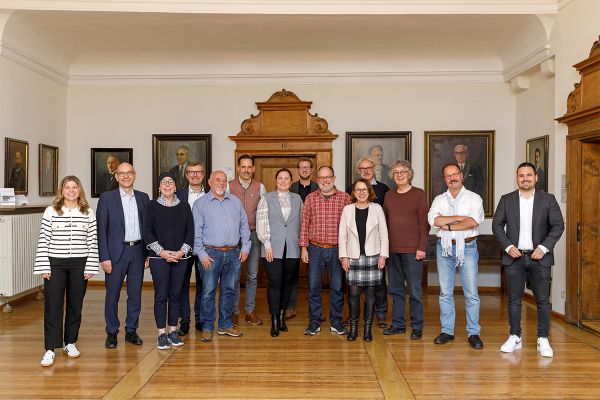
68, 71, 504, 86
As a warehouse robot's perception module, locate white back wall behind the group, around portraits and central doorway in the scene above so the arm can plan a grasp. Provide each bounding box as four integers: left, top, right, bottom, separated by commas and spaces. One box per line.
67, 83, 515, 286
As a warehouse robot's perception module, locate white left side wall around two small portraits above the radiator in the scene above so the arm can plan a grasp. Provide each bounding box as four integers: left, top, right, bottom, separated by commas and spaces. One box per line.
0, 57, 67, 205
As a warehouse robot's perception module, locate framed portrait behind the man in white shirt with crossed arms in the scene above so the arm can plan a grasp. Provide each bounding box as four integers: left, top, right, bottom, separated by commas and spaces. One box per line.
425, 131, 495, 217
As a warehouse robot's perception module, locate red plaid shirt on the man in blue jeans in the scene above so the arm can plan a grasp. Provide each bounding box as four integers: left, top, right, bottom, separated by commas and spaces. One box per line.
298, 189, 351, 247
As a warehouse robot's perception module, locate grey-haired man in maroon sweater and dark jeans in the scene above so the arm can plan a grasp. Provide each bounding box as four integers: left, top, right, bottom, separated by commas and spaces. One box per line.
383, 161, 429, 340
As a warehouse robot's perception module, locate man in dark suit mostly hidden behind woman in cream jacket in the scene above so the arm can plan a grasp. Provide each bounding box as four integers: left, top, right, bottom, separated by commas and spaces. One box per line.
344, 157, 390, 329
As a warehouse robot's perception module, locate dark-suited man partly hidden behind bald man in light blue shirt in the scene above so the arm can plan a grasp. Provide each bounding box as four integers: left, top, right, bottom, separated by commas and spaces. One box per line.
177, 162, 210, 336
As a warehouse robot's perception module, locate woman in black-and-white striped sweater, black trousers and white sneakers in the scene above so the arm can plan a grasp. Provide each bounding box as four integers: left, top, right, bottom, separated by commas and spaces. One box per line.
33, 175, 99, 367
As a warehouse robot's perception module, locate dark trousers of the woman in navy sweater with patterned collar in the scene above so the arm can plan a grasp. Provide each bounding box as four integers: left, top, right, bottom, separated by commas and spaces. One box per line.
150, 258, 188, 329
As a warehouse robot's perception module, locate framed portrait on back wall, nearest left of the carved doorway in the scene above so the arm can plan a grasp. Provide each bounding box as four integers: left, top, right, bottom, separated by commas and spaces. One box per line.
152, 134, 212, 197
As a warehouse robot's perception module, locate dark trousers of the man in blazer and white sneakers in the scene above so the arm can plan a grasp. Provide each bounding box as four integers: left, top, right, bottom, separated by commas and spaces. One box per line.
504, 255, 552, 337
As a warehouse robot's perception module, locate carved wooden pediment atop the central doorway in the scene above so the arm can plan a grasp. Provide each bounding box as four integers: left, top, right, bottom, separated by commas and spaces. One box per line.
237, 89, 332, 137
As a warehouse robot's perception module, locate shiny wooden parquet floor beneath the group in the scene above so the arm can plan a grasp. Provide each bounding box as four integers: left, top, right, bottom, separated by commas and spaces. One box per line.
0, 286, 600, 400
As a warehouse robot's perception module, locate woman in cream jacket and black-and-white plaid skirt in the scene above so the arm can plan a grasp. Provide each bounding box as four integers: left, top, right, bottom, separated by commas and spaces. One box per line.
338, 179, 388, 342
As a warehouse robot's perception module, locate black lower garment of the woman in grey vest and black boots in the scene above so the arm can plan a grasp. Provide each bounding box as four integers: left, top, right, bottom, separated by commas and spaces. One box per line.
263, 250, 300, 314
